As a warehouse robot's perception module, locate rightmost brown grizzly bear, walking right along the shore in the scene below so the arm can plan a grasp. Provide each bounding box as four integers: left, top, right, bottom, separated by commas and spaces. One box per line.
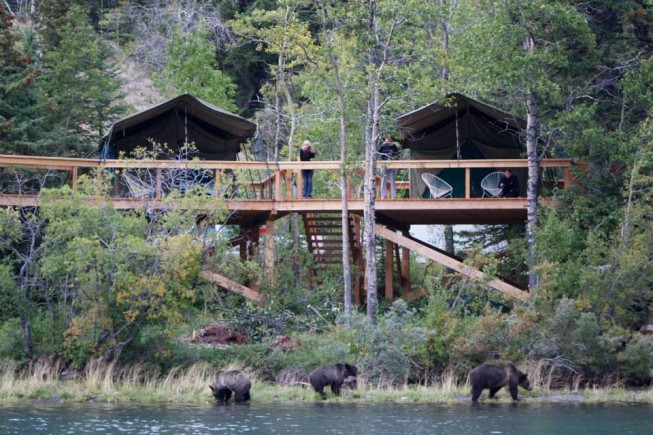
469, 364, 531, 402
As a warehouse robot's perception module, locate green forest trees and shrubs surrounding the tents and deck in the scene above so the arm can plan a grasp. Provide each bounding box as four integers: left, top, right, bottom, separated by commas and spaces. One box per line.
0, 0, 653, 385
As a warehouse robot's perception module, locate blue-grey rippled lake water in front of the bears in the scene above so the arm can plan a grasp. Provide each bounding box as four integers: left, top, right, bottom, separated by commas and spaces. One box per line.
0, 402, 653, 435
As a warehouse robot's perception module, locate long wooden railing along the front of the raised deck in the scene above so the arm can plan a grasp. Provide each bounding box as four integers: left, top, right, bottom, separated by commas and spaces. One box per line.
0, 155, 574, 201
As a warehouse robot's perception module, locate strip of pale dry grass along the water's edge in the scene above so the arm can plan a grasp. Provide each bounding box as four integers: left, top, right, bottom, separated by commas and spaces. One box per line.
0, 362, 653, 404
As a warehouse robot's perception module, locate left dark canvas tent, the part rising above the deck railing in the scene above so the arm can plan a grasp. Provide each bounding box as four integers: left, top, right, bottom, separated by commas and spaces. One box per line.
100, 94, 256, 160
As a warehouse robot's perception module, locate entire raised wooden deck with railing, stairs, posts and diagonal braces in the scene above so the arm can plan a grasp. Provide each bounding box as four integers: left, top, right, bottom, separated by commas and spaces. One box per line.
0, 155, 573, 304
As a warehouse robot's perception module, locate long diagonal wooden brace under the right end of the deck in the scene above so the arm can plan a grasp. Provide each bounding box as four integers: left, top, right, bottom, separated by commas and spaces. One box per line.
374, 224, 530, 302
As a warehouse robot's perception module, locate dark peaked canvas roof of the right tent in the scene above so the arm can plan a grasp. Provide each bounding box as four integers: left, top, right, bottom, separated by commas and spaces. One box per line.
396, 93, 526, 140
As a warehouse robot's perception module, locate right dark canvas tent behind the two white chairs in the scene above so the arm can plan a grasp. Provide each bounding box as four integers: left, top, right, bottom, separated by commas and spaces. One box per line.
396, 93, 527, 198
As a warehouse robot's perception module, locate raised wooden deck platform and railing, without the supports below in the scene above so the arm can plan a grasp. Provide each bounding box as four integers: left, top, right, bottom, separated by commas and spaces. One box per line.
0, 155, 572, 228
